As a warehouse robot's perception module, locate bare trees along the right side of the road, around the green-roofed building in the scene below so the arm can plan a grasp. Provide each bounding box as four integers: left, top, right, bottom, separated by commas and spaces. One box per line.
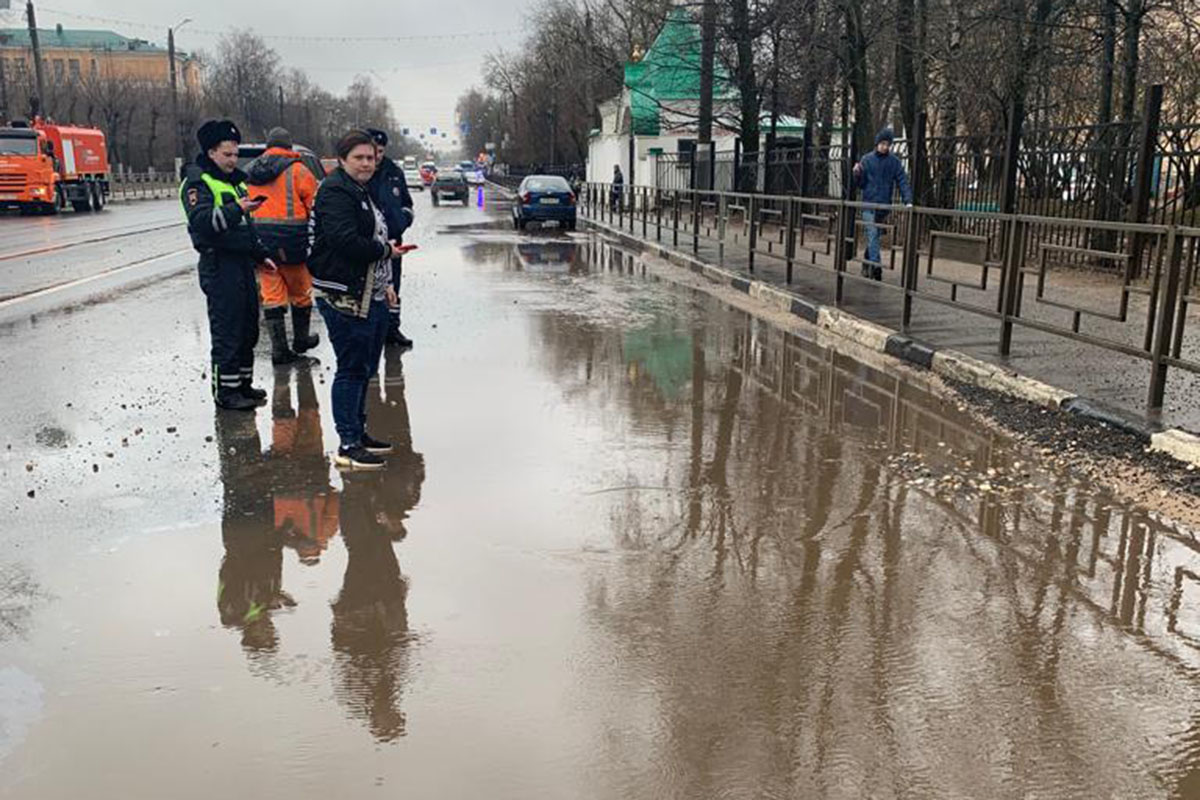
460, 0, 1200, 162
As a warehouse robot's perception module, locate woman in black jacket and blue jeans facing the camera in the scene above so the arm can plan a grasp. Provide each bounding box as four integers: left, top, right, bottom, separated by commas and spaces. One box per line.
308, 131, 402, 469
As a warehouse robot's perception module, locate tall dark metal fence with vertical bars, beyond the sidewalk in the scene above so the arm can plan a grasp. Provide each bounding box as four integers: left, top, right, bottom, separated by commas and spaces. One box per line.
654, 86, 1200, 249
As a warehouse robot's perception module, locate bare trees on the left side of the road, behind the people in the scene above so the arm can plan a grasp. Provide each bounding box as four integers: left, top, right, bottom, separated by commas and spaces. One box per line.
6, 31, 424, 172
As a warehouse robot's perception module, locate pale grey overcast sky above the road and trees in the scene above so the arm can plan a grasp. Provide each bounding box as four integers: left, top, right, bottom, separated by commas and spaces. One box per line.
0, 0, 535, 142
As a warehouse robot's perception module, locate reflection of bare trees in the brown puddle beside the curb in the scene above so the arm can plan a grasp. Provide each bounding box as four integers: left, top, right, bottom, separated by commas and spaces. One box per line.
562, 311, 1200, 796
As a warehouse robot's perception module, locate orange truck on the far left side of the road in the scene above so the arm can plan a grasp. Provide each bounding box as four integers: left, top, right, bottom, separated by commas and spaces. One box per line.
0, 120, 108, 213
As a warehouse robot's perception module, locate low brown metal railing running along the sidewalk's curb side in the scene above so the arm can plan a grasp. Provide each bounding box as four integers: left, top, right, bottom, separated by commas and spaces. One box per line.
582, 184, 1200, 409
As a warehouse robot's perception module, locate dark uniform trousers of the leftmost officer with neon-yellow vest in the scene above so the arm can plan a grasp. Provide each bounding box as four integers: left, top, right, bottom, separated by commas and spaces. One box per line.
198, 252, 258, 392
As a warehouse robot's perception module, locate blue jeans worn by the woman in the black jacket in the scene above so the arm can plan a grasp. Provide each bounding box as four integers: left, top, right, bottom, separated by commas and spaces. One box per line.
317, 297, 389, 447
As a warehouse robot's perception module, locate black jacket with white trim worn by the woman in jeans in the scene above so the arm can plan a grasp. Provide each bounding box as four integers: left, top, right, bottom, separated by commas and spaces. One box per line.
308, 167, 390, 317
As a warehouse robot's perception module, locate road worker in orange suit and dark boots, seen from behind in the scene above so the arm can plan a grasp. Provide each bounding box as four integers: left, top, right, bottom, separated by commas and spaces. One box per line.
246, 127, 320, 365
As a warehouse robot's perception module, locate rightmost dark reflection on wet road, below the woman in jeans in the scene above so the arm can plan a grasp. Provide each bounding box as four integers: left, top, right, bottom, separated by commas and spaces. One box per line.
330, 350, 425, 741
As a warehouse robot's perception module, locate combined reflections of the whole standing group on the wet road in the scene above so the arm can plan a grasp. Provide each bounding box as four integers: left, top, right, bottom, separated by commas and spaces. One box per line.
216, 350, 425, 741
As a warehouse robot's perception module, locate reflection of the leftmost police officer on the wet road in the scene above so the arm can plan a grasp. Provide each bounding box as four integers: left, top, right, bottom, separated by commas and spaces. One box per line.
216, 414, 295, 656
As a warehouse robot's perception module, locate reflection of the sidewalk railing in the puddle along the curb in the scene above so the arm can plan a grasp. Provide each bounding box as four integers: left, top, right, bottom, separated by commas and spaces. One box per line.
733, 323, 1200, 670
